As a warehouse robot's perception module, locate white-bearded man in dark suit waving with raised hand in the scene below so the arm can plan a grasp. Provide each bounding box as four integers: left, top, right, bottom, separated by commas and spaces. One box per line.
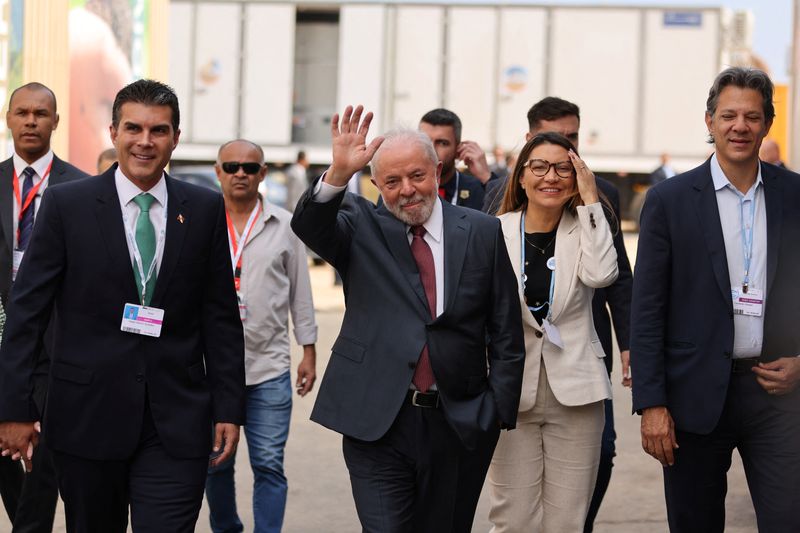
292, 106, 525, 532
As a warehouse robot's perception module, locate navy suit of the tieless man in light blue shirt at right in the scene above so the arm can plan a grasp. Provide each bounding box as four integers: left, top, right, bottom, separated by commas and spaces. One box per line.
631, 161, 800, 532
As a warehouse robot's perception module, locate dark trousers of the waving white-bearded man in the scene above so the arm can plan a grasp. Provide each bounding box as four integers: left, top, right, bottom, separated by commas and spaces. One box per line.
342, 396, 500, 533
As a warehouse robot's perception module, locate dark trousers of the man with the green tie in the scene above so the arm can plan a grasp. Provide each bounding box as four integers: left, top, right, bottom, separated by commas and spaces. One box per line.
53, 407, 208, 533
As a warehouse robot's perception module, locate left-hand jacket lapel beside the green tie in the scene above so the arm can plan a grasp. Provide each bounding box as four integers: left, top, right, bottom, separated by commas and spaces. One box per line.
95, 165, 139, 303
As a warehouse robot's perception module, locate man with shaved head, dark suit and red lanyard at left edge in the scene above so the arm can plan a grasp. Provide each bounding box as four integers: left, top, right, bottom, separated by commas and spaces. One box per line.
0, 82, 87, 532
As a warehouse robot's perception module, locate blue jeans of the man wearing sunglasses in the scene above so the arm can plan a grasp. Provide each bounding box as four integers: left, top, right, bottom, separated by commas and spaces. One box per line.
206, 371, 292, 533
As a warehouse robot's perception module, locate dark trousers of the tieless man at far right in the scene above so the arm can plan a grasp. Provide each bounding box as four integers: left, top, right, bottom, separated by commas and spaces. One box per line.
664, 372, 800, 533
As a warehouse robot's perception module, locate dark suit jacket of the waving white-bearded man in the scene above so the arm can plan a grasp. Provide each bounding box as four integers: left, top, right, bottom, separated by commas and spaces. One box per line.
292, 185, 525, 448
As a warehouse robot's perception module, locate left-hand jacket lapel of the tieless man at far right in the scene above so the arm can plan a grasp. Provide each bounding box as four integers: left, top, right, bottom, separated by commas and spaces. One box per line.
693, 160, 733, 310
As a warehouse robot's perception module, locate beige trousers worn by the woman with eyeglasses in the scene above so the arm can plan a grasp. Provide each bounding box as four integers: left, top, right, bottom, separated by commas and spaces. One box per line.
488, 361, 605, 533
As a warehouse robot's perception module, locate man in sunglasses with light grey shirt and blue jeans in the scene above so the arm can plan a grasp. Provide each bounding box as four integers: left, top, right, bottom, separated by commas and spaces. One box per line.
206, 139, 317, 533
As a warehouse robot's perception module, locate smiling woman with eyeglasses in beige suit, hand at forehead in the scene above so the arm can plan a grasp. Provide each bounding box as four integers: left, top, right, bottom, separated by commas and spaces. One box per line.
488, 133, 617, 533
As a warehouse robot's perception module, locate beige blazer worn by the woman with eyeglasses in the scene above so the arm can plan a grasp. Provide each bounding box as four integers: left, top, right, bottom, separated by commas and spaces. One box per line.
499, 202, 617, 412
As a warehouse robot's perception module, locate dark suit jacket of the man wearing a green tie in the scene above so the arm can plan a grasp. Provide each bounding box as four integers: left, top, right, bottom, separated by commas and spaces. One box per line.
0, 165, 245, 460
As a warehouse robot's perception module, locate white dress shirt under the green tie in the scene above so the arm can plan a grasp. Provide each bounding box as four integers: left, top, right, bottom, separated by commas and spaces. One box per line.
114, 167, 167, 278
